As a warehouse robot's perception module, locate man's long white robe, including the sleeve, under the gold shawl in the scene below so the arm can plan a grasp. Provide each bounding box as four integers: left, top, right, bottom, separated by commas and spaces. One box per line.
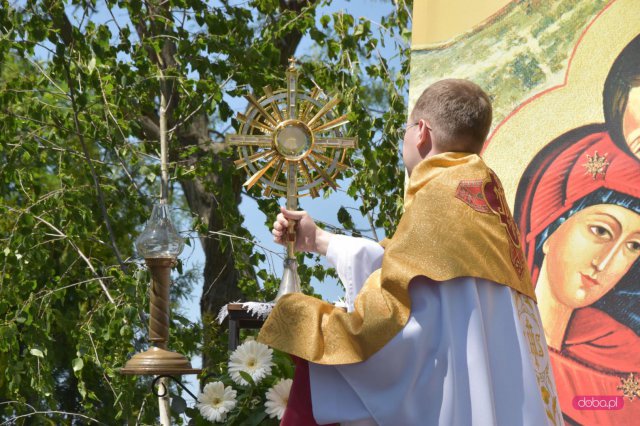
309, 236, 562, 426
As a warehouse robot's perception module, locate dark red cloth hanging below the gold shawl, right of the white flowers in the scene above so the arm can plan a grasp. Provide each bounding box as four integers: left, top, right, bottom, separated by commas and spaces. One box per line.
280, 356, 338, 426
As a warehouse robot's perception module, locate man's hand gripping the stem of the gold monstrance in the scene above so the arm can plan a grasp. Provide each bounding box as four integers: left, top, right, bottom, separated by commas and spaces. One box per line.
271, 207, 333, 255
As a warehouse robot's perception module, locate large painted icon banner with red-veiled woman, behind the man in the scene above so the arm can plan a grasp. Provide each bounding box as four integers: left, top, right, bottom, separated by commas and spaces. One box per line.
409, 0, 640, 425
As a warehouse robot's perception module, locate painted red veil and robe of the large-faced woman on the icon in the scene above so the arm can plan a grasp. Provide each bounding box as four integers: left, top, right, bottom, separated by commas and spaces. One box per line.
518, 132, 640, 426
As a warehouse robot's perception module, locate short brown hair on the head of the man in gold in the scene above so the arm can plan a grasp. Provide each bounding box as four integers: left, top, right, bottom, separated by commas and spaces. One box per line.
411, 79, 492, 152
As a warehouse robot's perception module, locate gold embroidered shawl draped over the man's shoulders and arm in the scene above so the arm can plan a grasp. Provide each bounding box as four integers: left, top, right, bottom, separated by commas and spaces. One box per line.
258, 153, 535, 365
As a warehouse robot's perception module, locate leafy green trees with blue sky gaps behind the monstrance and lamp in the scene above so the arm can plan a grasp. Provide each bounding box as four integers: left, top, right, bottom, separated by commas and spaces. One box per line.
0, 0, 411, 424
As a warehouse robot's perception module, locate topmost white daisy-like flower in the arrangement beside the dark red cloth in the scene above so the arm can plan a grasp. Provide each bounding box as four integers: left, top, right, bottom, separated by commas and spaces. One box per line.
229, 340, 273, 386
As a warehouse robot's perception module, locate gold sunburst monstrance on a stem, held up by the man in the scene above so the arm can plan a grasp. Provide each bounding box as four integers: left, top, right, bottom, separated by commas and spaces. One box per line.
226, 59, 357, 300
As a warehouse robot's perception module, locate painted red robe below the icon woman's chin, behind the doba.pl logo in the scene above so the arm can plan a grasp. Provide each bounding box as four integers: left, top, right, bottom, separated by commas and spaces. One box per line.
549, 308, 640, 426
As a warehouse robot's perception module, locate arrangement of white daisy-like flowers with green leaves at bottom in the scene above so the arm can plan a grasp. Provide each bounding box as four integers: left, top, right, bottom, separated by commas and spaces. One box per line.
185, 338, 293, 426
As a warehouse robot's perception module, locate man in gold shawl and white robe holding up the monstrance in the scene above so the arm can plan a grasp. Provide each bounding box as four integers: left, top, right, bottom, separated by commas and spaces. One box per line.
258, 79, 562, 426
